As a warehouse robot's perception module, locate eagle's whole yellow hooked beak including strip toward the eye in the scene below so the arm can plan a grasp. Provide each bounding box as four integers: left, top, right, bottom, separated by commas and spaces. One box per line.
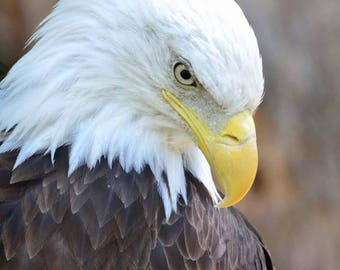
162, 90, 258, 208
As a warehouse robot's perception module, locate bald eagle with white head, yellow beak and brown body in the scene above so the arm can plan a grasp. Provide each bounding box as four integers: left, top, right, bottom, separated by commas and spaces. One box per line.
0, 0, 273, 270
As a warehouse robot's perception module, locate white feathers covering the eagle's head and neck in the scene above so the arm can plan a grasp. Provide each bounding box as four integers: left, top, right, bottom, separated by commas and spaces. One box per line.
0, 0, 263, 216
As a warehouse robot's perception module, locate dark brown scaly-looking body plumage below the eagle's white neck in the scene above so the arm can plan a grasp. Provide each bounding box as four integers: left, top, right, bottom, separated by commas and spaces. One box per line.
0, 147, 273, 270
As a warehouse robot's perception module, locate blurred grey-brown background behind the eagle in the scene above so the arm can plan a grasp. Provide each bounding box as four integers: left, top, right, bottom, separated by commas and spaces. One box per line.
0, 0, 340, 270
